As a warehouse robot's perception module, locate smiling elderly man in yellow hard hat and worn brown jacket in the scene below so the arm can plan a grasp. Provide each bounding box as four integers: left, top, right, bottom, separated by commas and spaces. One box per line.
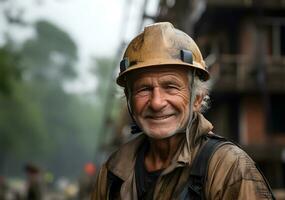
93, 22, 274, 200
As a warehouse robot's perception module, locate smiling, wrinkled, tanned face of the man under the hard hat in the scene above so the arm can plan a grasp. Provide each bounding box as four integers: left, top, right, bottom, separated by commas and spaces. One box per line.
131, 67, 190, 139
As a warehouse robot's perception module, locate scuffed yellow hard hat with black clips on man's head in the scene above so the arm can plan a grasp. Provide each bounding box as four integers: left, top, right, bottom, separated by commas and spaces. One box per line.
117, 22, 209, 87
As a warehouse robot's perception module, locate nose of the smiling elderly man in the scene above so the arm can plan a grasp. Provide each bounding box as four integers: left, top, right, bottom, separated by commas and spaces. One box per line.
150, 87, 167, 111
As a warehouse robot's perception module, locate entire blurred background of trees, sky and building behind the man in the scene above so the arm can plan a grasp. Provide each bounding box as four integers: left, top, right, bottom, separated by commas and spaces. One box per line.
0, 0, 285, 200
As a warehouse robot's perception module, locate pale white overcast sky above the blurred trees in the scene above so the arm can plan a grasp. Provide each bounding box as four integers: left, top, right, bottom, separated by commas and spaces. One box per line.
0, 0, 157, 90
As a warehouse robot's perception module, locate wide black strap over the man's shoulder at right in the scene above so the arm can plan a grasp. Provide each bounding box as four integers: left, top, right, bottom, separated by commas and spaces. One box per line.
179, 134, 232, 200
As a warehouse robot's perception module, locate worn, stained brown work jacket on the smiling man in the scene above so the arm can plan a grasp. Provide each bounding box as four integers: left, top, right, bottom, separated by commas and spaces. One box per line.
92, 113, 272, 200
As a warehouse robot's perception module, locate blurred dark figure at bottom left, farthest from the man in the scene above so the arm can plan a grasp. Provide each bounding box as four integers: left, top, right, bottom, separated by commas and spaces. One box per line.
25, 163, 43, 200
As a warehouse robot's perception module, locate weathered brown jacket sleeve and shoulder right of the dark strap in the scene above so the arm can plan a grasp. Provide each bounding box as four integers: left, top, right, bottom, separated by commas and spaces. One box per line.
206, 138, 272, 199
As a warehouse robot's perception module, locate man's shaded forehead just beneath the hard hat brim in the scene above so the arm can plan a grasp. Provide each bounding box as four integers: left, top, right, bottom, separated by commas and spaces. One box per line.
127, 66, 190, 87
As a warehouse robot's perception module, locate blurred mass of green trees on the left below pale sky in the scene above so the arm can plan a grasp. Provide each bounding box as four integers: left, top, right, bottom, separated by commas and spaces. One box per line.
0, 21, 98, 176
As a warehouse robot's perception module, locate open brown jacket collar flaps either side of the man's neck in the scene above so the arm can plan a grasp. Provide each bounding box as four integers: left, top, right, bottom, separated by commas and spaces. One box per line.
107, 113, 213, 181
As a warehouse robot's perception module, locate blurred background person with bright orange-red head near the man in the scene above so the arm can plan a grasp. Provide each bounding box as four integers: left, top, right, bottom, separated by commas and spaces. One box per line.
78, 162, 96, 200
